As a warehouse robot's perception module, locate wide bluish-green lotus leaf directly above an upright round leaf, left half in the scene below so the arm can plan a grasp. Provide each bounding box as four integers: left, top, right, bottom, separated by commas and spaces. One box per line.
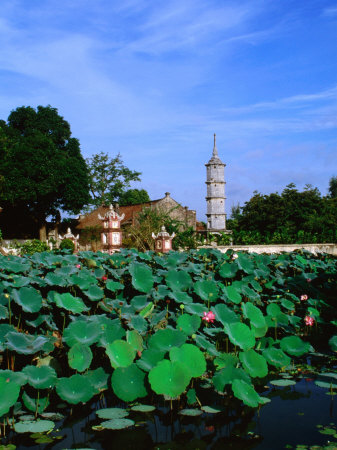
63, 320, 102, 347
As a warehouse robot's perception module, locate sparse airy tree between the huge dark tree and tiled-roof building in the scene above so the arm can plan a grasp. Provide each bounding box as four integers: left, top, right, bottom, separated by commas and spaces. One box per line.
86, 152, 141, 207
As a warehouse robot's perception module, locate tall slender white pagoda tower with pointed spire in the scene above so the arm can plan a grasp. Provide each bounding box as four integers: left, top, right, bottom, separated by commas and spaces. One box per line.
205, 134, 226, 231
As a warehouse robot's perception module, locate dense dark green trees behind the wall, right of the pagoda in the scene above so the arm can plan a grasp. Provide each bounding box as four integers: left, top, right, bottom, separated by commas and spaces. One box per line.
227, 179, 337, 244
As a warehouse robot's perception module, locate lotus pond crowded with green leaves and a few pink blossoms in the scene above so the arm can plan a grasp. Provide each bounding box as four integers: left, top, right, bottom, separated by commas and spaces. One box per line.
0, 249, 337, 449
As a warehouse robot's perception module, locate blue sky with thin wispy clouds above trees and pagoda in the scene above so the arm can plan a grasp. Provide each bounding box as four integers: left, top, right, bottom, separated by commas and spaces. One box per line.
0, 0, 337, 220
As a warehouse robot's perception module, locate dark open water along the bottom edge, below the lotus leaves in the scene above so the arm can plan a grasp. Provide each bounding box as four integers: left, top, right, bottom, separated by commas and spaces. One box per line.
3, 375, 337, 450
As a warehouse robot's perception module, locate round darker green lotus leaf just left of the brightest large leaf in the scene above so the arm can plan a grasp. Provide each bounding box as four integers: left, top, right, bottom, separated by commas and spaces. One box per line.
111, 364, 147, 402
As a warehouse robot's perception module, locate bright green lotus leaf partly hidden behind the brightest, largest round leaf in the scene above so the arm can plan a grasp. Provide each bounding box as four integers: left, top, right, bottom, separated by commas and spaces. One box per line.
170, 344, 206, 378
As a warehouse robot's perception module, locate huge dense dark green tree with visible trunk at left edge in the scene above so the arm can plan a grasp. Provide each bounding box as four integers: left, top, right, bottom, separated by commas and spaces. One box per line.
0, 106, 89, 240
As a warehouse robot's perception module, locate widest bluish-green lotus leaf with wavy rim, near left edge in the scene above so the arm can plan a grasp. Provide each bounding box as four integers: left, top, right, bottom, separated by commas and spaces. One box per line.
6, 331, 54, 355
